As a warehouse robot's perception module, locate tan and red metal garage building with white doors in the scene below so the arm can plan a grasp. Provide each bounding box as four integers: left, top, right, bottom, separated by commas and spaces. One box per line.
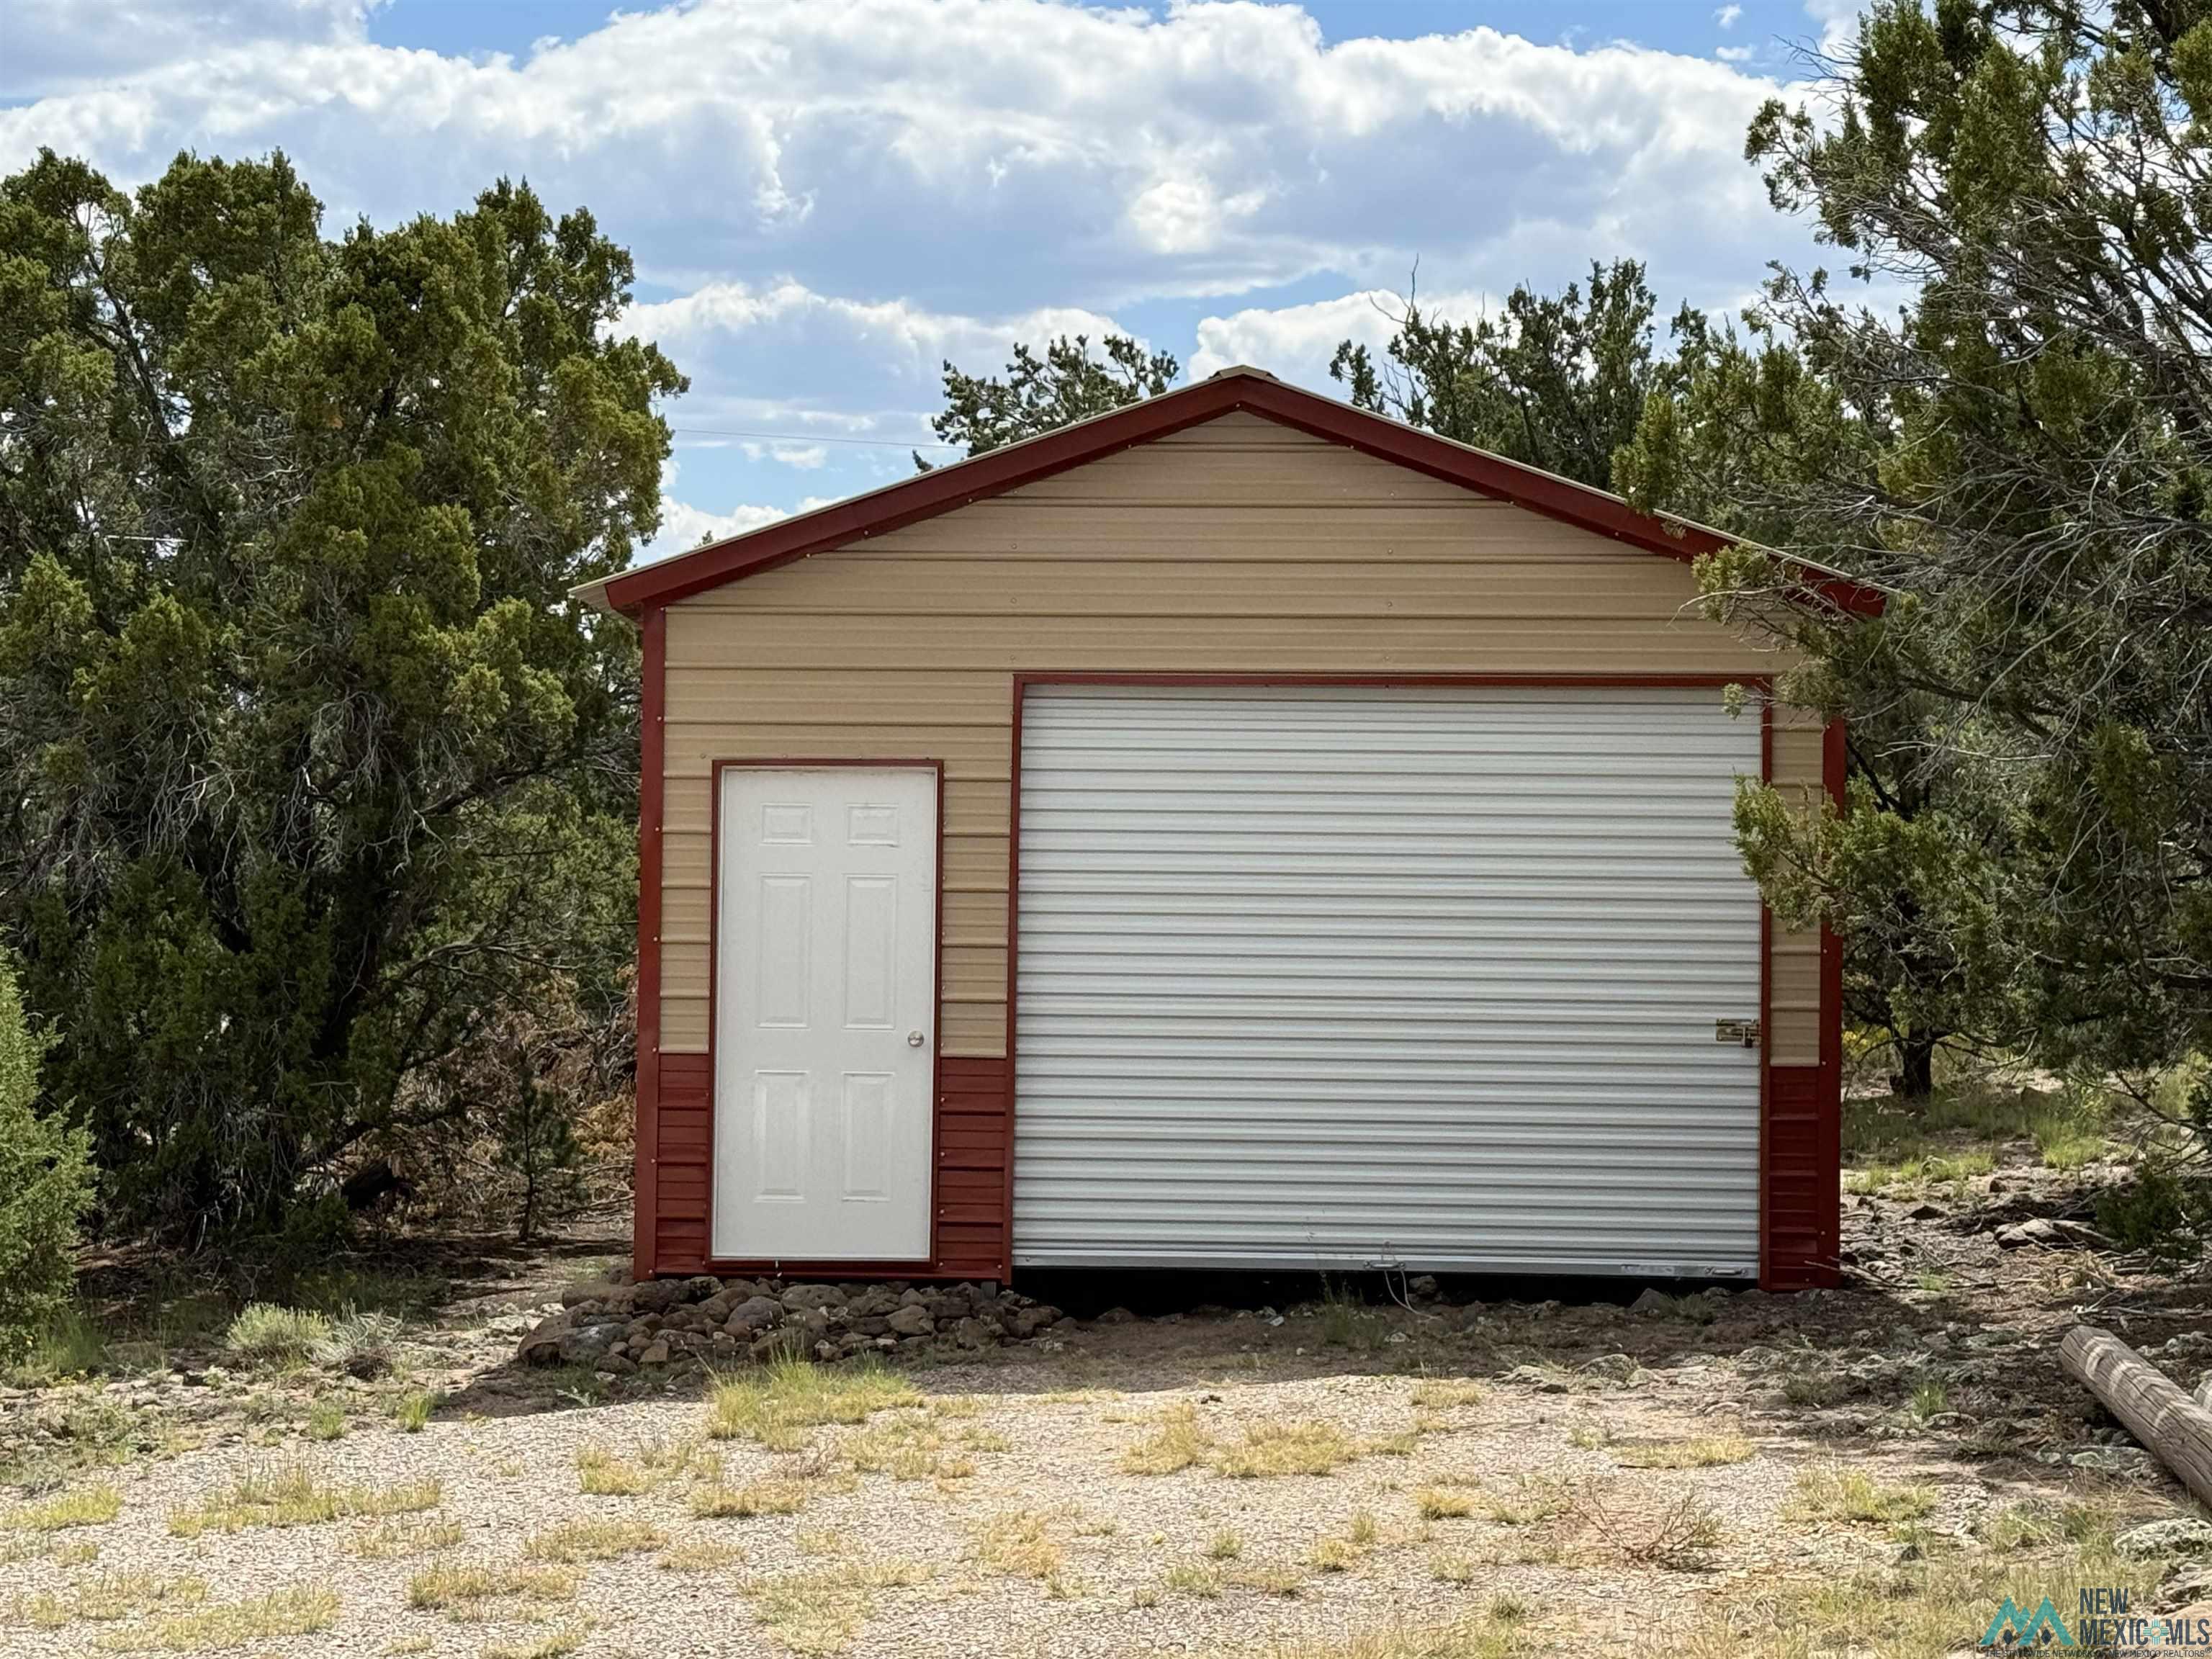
584, 369, 1843, 1287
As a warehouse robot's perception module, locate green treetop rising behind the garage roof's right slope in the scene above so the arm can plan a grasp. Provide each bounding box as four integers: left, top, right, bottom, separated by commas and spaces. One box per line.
1329, 258, 1706, 489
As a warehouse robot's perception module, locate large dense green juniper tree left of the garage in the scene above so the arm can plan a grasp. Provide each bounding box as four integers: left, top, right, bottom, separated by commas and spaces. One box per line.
0, 153, 683, 1250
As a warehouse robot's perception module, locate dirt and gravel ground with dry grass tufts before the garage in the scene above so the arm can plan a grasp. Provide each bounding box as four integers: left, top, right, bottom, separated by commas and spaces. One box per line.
13, 1148, 2212, 1659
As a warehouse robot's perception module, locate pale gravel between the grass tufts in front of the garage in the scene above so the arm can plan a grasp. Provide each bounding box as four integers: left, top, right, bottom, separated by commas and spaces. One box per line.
0, 1327, 2008, 1659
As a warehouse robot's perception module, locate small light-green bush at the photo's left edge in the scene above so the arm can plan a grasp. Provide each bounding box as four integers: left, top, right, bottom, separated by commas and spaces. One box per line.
0, 956, 93, 1358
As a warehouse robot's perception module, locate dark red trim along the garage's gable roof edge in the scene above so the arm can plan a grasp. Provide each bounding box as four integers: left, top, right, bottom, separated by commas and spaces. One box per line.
573, 367, 1878, 617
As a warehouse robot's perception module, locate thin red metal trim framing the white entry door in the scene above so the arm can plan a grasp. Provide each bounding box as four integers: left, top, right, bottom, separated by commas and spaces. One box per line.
706, 755, 945, 1279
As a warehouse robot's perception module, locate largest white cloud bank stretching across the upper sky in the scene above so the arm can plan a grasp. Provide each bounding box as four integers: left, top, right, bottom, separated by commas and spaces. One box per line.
0, 0, 1772, 310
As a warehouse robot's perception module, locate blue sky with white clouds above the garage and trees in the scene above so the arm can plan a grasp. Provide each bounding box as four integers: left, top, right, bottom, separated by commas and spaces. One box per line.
0, 0, 1856, 553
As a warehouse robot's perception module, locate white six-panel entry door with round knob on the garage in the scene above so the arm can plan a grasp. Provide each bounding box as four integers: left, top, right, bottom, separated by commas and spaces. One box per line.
714, 765, 938, 1261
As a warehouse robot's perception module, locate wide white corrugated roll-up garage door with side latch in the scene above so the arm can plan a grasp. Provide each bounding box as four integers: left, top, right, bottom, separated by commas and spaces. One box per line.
1013, 685, 1761, 1274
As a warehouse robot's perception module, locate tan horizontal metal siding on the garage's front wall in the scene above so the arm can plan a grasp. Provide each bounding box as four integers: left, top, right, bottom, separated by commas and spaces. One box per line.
662, 413, 1820, 1059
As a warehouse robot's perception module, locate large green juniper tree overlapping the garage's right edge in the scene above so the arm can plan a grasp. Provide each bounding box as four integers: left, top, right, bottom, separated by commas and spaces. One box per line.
1619, 0, 2212, 1110
